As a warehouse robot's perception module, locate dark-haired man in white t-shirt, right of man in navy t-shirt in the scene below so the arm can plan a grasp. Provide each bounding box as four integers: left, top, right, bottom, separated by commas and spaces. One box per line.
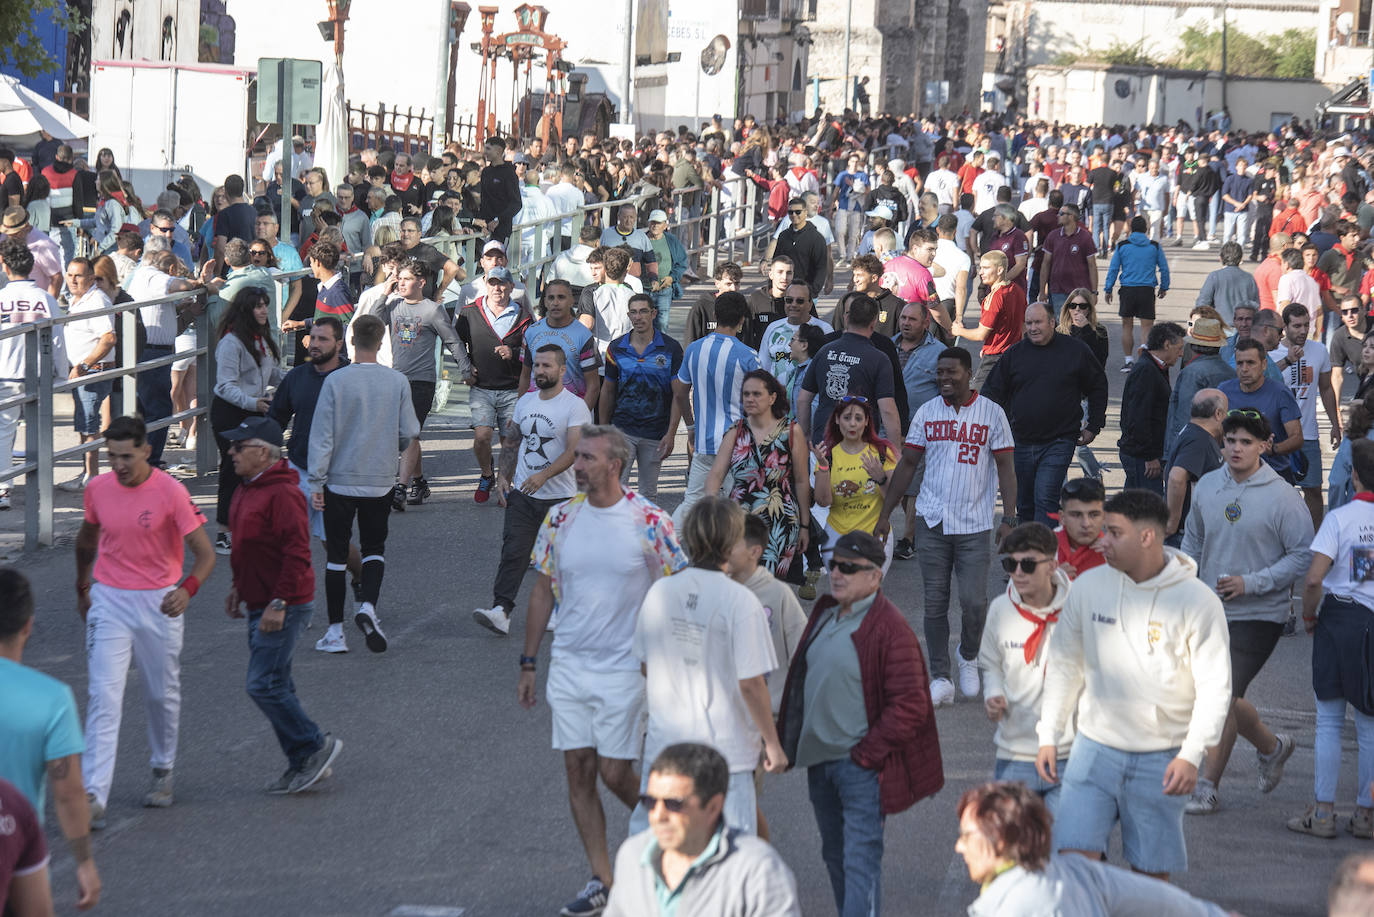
1270, 302, 1341, 528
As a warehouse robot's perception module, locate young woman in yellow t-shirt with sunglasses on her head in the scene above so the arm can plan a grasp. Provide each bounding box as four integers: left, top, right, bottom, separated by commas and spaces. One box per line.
812, 395, 897, 573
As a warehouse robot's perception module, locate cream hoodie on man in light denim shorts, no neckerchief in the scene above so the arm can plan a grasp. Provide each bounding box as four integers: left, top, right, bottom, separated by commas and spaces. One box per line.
1036, 549, 1231, 764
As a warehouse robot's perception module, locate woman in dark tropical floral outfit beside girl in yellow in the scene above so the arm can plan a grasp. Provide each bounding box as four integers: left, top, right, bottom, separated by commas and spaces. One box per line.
706, 370, 811, 582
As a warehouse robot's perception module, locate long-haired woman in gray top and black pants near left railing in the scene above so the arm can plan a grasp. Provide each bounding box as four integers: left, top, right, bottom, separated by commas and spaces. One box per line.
210, 286, 284, 554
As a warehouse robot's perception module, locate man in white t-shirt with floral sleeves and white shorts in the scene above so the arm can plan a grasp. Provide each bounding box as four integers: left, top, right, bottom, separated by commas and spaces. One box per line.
517, 425, 687, 914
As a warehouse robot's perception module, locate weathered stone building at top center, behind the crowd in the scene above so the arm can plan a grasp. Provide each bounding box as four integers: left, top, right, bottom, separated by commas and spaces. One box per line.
811, 0, 988, 114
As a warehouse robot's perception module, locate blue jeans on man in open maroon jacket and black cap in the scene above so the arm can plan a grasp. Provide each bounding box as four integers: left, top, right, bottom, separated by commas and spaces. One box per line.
807, 758, 883, 917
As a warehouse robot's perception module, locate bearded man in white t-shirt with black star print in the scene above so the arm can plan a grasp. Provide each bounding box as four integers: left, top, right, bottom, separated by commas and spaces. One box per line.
473, 344, 592, 637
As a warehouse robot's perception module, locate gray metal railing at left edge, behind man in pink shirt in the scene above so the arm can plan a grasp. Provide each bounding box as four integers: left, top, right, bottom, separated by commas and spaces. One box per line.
0, 290, 217, 550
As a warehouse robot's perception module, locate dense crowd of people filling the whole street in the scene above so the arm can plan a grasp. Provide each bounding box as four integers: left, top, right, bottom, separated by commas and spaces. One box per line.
8, 113, 1374, 917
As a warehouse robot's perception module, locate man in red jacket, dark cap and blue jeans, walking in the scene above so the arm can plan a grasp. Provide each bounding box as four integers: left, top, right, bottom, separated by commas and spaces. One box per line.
224, 417, 344, 795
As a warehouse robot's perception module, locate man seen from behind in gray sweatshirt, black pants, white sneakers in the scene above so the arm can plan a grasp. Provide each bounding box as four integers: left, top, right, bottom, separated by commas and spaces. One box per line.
309, 315, 420, 653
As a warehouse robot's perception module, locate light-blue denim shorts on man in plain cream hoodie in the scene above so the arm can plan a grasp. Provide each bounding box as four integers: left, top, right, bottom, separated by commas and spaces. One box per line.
1054, 733, 1189, 874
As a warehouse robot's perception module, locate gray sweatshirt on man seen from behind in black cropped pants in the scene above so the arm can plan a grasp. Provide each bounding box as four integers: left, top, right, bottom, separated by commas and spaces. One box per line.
309, 363, 420, 496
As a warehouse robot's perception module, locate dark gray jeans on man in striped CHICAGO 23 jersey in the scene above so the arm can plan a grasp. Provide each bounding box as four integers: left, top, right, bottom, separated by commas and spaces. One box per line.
916, 520, 992, 679
